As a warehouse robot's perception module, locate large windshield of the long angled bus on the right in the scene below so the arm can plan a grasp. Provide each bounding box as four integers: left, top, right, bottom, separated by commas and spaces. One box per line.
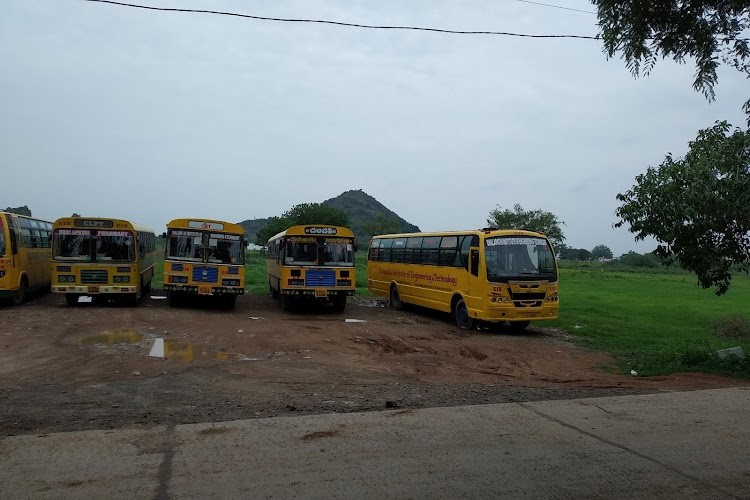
484, 236, 557, 282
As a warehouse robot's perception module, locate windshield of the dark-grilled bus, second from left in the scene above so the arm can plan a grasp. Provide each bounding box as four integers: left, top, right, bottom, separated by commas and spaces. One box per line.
54, 229, 135, 262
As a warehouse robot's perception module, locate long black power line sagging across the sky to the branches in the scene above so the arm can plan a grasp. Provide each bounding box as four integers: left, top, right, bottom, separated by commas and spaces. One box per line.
85, 0, 599, 40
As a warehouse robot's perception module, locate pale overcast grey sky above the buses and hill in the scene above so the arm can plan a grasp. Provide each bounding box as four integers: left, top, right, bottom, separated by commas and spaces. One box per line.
0, 0, 748, 256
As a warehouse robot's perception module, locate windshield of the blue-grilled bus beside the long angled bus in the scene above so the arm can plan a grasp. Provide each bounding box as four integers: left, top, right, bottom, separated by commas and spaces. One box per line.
284, 236, 354, 267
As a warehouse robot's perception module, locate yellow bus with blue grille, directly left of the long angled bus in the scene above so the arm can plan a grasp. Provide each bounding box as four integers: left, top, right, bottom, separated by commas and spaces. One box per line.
266, 224, 356, 311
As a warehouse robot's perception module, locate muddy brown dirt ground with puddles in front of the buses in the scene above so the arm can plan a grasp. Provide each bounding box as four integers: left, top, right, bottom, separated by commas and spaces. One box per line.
0, 290, 743, 435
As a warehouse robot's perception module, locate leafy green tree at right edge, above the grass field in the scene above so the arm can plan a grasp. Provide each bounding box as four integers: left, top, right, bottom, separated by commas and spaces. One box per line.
615, 122, 750, 295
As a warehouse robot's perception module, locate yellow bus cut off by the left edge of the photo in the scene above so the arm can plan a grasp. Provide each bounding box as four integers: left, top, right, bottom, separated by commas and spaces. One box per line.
0, 212, 52, 305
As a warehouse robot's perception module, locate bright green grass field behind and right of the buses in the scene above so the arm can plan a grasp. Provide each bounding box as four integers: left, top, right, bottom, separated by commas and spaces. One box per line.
153, 251, 750, 378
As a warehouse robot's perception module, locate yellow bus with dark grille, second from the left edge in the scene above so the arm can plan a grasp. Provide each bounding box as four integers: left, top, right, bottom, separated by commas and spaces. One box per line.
52, 217, 156, 305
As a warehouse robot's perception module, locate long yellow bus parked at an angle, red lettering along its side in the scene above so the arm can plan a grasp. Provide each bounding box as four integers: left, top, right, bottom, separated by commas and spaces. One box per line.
367, 229, 560, 329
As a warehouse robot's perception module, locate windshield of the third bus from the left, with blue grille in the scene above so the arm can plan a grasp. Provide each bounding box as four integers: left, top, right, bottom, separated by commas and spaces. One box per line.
167, 229, 244, 264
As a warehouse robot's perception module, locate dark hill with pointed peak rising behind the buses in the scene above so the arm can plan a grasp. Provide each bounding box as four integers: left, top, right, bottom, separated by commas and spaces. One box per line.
240, 189, 419, 242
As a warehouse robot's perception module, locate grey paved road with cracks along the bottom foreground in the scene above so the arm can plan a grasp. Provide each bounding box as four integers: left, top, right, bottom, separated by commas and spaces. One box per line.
0, 387, 750, 499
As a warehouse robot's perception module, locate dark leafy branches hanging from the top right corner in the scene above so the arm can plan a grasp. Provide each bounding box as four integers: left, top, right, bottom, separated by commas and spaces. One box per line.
593, 0, 750, 114
